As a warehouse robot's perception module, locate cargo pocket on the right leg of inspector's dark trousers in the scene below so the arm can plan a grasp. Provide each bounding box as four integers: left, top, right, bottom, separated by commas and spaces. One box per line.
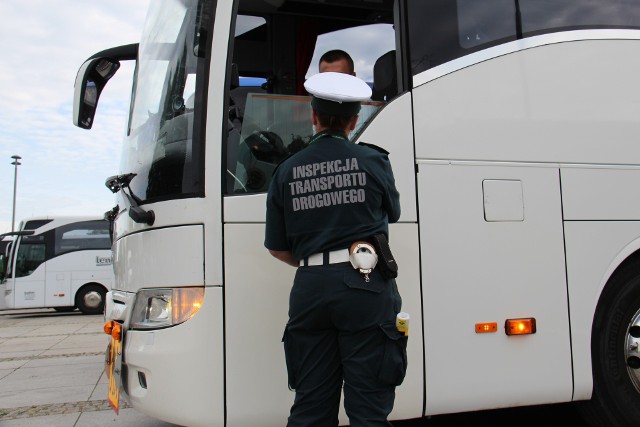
378, 322, 407, 386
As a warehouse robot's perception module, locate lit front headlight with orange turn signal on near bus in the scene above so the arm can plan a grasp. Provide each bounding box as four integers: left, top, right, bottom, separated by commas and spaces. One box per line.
129, 287, 204, 329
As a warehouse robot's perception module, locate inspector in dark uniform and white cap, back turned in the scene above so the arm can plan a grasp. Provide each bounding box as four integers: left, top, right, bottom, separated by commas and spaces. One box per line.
265, 73, 407, 427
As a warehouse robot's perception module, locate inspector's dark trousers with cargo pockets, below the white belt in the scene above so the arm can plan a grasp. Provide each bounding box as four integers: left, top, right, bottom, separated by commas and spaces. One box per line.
283, 263, 407, 427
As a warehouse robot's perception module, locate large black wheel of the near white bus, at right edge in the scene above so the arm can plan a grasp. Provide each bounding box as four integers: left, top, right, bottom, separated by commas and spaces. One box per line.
578, 258, 640, 427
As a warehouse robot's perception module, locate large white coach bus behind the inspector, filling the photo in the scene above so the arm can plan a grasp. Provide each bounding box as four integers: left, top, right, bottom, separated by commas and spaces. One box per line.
74, 0, 640, 426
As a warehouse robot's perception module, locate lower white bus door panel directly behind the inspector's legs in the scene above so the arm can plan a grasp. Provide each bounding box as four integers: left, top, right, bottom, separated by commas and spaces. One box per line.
224, 224, 424, 427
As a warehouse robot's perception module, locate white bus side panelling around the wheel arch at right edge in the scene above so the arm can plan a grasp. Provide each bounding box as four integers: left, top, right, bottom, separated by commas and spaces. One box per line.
562, 166, 640, 399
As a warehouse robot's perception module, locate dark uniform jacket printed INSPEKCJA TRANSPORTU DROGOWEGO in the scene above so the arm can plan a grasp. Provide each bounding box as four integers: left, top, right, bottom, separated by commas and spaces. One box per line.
265, 131, 400, 260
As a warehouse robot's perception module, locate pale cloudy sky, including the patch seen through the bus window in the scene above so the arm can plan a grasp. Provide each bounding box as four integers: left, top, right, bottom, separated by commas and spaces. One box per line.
0, 0, 393, 233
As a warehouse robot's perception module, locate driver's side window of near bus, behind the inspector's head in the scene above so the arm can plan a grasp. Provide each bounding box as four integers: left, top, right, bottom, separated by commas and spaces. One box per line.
225, 1, 397, 194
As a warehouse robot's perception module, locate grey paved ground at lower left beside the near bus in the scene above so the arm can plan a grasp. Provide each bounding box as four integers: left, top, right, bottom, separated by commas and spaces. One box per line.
0, 310, 178, 427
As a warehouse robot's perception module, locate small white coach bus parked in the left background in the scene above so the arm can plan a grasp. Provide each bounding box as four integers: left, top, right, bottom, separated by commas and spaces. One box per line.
2, 217, 114, 314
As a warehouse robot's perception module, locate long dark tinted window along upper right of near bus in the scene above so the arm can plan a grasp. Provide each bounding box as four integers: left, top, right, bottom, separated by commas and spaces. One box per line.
407, 0, 640, 75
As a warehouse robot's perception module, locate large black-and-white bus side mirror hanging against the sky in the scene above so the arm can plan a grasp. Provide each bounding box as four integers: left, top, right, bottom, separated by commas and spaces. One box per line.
73, 58, 120, 129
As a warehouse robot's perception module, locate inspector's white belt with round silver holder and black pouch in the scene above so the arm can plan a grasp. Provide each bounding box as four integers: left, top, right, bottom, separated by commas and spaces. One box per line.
300, 233, 398, 282
